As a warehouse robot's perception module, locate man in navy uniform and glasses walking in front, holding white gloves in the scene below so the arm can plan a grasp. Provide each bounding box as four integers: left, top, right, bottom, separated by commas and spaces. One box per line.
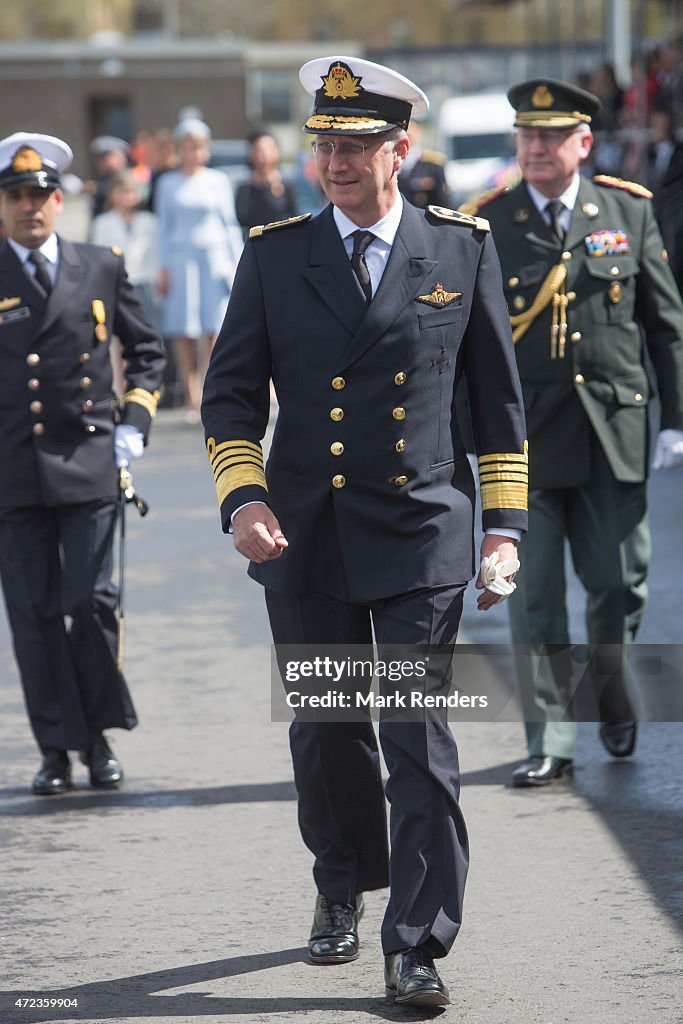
203, 56, 526, 1006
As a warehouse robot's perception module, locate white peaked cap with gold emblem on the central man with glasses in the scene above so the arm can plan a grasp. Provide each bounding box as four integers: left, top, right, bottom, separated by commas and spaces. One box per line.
299, 56, 429, 135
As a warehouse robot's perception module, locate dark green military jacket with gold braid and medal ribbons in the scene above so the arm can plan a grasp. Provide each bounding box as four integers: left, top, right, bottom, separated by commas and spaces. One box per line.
463, 178, 683, 487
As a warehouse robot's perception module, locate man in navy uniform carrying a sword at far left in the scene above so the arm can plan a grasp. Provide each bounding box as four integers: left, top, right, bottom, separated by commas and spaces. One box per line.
0, 132, 165, 796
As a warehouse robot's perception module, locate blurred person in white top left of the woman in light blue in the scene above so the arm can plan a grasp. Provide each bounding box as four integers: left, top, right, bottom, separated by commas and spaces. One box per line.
89, 169, 160, 394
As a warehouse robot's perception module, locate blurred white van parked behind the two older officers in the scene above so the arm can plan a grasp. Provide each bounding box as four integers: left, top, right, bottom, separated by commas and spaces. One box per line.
437, 92, 518, 204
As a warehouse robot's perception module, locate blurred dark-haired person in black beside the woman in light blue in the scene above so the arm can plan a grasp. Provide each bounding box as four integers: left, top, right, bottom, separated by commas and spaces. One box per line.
234, 130, 297, 234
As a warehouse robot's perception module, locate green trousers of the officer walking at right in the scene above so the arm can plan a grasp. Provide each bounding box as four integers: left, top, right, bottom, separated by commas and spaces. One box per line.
508, 438, 650, 758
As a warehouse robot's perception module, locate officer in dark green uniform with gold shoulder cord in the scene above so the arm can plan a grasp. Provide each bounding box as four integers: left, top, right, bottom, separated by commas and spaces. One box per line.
462, 79, 683, 785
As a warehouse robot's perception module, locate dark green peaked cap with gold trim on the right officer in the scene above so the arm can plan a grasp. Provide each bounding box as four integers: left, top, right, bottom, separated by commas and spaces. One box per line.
508, 78, 600, 128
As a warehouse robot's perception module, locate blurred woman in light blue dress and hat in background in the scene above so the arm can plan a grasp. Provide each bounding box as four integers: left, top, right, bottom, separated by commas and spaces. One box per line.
155, 118, 243, 423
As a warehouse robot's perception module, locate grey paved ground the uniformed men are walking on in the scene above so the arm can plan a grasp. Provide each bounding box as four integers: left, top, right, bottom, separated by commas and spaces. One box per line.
0, 413, 683, 1024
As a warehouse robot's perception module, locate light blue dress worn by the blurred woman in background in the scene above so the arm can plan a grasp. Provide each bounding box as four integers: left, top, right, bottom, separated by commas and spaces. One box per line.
156, 167, 243, 338
